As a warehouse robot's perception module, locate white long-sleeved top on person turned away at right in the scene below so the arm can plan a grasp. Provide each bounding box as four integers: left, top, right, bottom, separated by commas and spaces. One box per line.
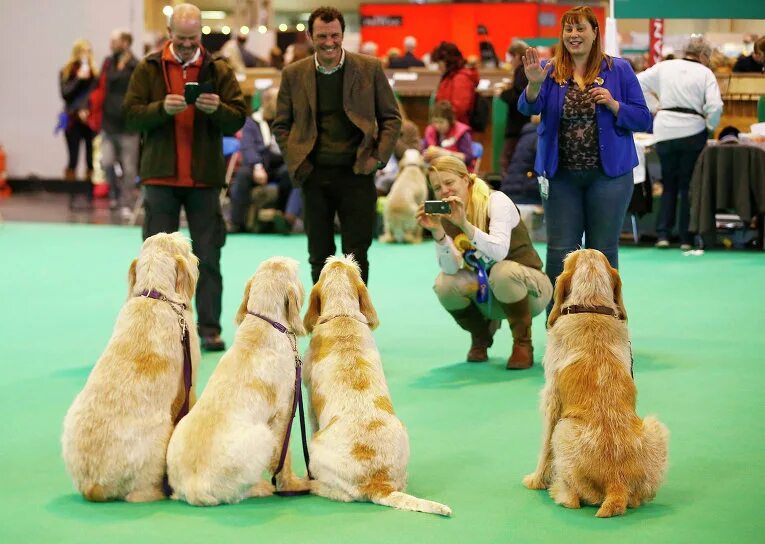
637, 59, 723, 142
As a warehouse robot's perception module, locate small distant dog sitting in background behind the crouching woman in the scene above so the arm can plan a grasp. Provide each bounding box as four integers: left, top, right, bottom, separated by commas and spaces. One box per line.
380, 149, 428, 244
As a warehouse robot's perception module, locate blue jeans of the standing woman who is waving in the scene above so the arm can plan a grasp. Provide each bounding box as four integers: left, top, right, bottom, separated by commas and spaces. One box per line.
542, 166, 634, 313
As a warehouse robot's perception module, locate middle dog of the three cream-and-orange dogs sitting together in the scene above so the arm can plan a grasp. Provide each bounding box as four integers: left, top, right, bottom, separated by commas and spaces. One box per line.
167, 257, 308, 506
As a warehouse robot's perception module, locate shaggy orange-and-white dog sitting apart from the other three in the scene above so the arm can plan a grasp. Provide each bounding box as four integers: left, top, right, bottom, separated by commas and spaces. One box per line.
523, 249, 669, 517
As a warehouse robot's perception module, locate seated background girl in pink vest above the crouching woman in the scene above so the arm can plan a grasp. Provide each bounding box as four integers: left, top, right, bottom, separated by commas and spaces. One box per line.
422, 100, 475, 172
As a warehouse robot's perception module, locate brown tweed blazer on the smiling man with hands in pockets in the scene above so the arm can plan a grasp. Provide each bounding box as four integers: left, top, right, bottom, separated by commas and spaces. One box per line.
272, 51, 401, 187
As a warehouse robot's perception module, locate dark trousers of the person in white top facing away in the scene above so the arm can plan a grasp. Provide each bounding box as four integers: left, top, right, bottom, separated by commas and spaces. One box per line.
656, 130, 707, 244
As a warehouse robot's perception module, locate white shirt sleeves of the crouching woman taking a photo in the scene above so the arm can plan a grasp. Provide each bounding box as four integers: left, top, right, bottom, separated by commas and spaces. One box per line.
436, 191, 521, 274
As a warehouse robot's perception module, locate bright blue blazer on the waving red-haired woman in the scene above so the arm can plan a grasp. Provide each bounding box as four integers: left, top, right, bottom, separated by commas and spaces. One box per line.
518, 57, 651, 179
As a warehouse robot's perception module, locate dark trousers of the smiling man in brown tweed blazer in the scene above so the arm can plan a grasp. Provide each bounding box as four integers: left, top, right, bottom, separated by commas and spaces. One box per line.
303, 166, 377, 283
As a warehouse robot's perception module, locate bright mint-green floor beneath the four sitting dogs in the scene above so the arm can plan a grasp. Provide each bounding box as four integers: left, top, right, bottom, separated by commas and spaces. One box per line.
0, 223, 765, 544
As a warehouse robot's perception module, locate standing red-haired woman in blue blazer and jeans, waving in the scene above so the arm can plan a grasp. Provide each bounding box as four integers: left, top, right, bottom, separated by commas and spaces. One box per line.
518, 6, 651, 312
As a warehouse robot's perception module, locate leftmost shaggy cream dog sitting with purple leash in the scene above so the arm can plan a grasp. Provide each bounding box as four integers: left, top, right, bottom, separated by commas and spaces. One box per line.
61, 232, 200, 502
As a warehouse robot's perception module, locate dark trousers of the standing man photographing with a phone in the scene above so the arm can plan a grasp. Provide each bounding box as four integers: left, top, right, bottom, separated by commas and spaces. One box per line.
143, 185, 226, 336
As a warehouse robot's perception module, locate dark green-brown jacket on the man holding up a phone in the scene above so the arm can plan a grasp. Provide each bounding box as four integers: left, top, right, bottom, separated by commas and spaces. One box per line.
123, 52, 247, 187
